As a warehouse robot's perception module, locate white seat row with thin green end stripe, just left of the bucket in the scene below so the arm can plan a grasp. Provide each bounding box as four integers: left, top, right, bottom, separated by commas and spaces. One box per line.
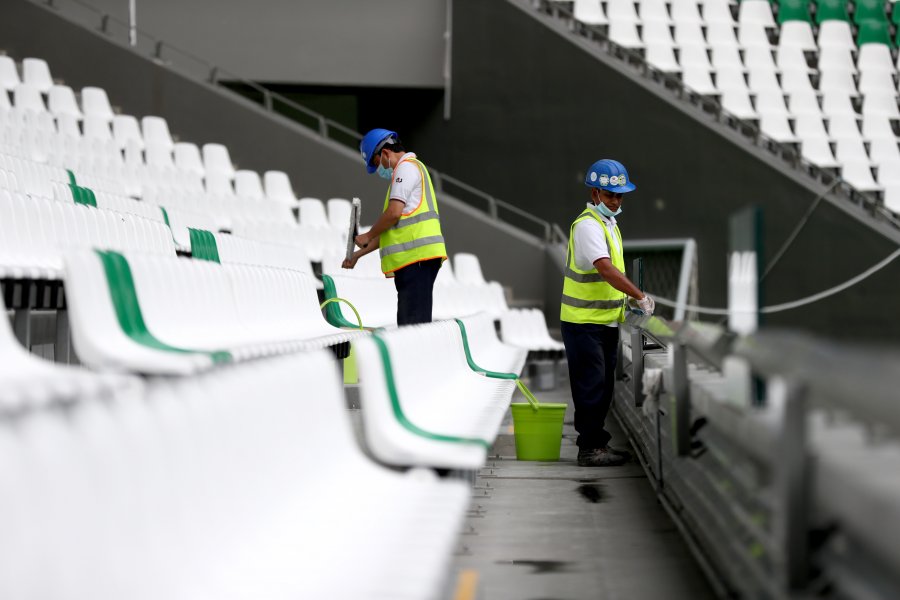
353, 321, 515, 470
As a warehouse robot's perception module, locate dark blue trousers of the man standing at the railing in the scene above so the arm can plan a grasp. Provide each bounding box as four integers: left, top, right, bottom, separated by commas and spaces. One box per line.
561, 321, 619, 450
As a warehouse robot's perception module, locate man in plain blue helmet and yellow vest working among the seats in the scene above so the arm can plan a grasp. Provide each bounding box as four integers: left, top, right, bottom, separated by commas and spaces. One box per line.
343, 129, 447, 325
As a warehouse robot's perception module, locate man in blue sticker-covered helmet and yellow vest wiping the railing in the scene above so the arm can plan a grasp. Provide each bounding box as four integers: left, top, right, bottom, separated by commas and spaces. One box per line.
560, 159, 654, 467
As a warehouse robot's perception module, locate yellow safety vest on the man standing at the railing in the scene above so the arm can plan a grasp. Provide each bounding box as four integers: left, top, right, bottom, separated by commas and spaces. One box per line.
559, 208, 625, 324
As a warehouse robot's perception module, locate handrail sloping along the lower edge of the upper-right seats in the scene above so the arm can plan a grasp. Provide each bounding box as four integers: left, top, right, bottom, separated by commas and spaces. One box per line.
533, 0, 900, 229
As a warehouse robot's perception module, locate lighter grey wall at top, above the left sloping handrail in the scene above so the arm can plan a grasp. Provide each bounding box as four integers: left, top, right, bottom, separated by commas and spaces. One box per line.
59, 0, 447, 87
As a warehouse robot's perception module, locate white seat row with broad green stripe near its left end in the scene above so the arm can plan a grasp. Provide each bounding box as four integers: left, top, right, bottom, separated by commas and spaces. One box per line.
65, 250, 359, 374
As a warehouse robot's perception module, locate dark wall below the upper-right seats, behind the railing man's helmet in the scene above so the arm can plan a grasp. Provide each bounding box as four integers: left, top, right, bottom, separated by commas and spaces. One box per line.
407, 0, 900, 340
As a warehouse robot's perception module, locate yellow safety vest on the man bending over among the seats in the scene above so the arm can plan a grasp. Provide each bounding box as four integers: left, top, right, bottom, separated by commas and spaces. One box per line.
378, 158, 447, 277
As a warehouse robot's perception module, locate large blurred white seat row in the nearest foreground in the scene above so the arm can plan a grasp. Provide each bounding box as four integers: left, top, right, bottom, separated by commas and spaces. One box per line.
0, 352, 470, 600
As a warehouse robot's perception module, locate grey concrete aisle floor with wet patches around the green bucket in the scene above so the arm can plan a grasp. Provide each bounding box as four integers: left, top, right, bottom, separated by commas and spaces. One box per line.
449, 378, 713, 600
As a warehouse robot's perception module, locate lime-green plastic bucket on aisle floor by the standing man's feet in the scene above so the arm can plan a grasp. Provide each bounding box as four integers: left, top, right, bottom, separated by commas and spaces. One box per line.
510, 402, 566, 462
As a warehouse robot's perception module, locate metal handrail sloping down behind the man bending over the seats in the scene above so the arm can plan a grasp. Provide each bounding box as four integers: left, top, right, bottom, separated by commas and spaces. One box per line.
37, 0, 568, 242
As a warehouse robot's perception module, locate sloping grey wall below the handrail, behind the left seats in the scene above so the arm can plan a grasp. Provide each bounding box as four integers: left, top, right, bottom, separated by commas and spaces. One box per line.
0, 0, 545, 300
